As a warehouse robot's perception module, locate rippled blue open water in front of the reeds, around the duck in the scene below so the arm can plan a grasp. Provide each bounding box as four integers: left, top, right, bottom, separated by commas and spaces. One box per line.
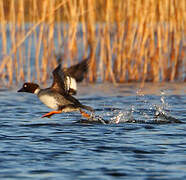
0, 83, 186, 180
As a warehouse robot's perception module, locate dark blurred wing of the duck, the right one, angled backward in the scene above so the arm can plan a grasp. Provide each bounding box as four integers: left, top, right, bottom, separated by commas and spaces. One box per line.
64, 57, 89, 82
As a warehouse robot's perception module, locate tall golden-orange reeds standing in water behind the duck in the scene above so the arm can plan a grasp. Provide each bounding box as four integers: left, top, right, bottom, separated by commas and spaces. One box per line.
0, 0, 186, 86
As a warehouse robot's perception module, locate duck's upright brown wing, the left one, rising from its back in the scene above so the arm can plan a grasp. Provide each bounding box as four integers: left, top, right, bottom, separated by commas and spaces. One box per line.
51, 64, 70, 95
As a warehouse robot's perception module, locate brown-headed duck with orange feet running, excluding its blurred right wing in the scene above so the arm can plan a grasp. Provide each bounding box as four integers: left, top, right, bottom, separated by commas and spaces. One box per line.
17, 64, 94, 118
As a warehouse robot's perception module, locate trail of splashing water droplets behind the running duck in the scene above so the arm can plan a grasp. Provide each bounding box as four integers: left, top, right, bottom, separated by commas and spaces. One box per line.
78, 90, 180, 124
